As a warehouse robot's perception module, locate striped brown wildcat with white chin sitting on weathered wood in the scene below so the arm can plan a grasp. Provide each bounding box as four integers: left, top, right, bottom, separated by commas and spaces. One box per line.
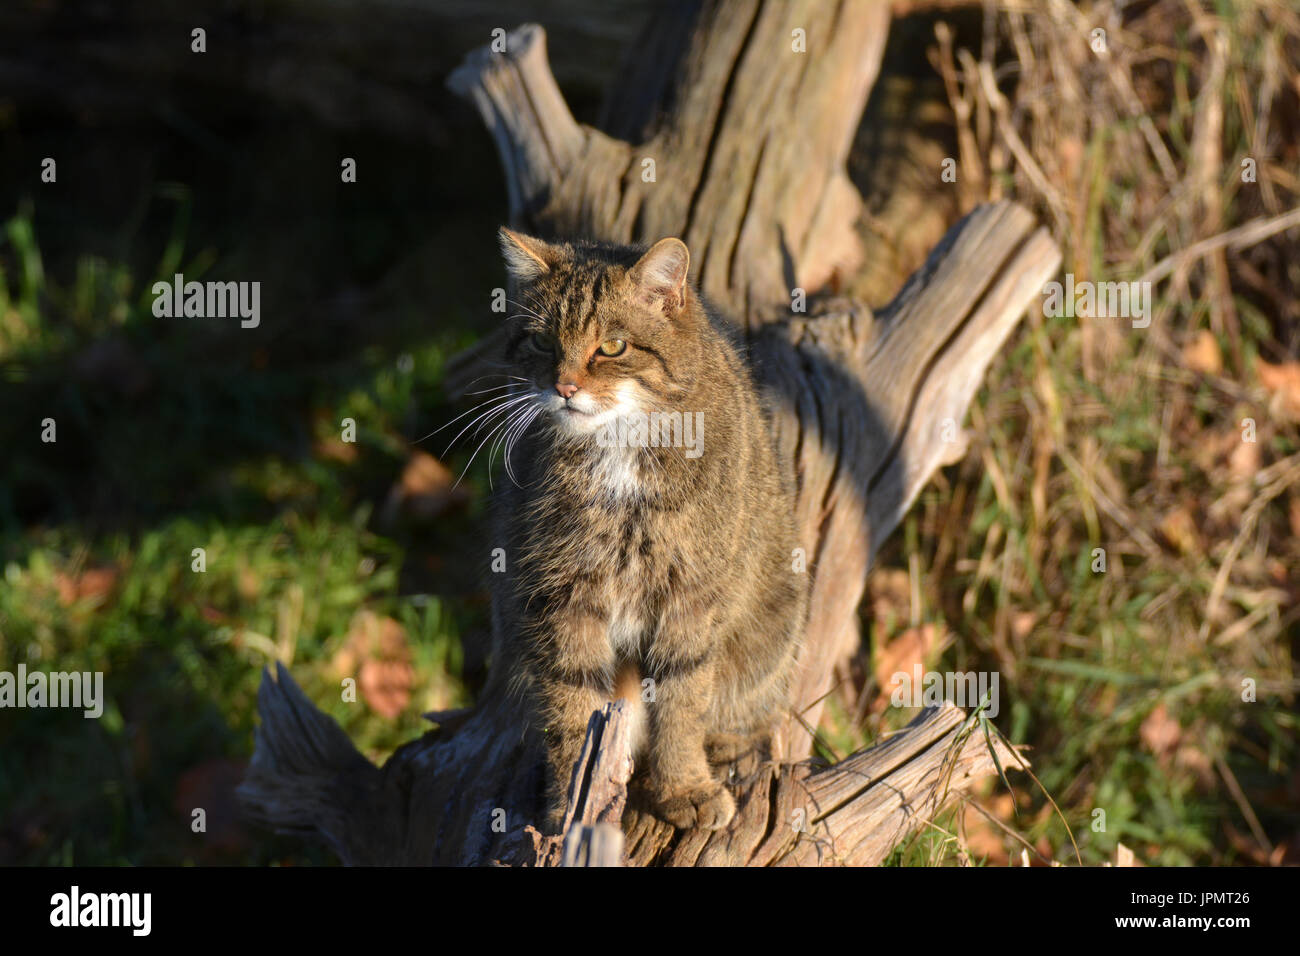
490, 229, 807, 830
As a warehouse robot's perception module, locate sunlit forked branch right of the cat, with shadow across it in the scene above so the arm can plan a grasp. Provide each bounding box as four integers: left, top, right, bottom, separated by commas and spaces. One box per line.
754, 203, 1060, 758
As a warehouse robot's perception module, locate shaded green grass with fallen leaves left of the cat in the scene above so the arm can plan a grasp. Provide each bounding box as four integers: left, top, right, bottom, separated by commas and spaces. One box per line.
0, 197, 482, 864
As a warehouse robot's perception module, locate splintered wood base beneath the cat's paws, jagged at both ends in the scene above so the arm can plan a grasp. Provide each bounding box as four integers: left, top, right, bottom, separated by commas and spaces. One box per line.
239, 666, 1027, 866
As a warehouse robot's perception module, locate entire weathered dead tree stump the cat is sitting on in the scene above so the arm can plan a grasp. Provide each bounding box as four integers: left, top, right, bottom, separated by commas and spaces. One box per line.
241, 0, 1061, 865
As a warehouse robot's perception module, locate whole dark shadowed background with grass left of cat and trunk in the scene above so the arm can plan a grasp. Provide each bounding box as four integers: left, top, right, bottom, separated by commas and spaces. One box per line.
0, 0, 644, 864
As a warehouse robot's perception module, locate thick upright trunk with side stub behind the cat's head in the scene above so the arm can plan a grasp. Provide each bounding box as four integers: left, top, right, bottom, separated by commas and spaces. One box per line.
449, 0, 889, 325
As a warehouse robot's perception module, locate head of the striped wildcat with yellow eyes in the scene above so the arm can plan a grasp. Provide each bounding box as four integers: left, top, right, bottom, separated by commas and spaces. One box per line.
501, 229, 699, 436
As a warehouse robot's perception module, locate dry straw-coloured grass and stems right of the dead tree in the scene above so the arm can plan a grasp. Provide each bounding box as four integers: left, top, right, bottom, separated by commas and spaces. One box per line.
822, 3, 1300, 865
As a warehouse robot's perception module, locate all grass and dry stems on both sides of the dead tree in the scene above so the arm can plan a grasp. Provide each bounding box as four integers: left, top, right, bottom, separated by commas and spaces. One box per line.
0, 4, 1300, 865
